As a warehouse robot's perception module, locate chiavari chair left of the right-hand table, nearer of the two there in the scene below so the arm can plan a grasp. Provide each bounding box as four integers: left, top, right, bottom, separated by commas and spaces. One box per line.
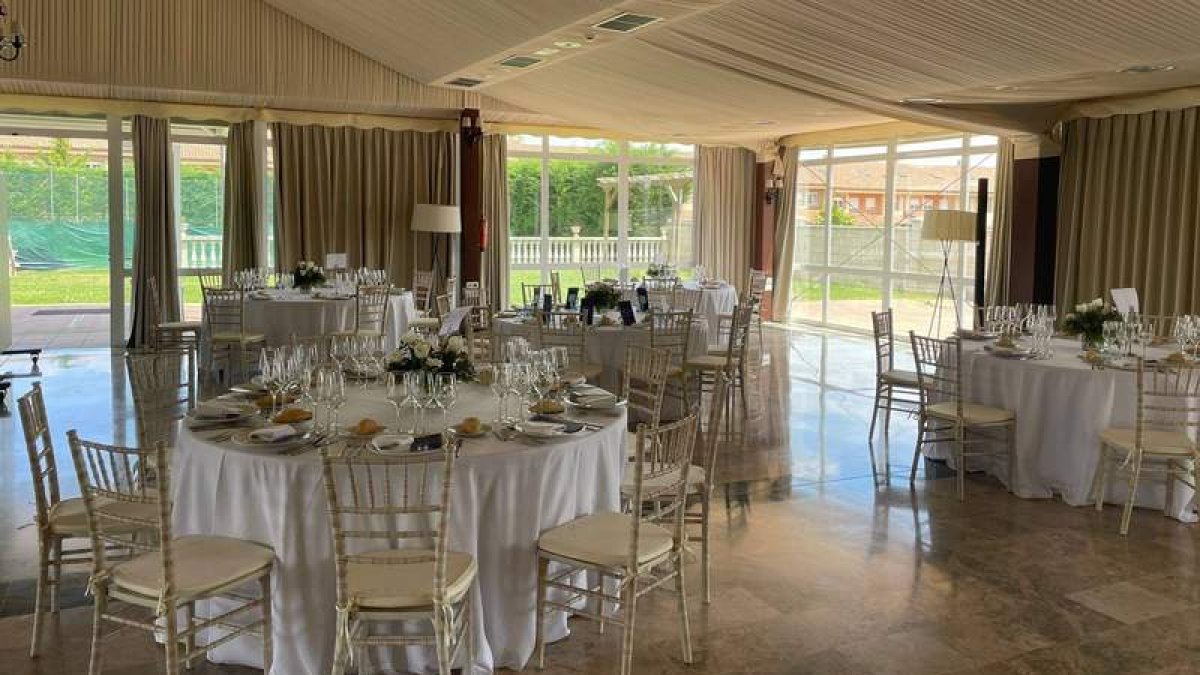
908, 331, 1016, 500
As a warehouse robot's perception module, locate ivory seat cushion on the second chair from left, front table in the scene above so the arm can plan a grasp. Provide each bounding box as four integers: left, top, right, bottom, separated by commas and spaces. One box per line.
112, 534, 275, 598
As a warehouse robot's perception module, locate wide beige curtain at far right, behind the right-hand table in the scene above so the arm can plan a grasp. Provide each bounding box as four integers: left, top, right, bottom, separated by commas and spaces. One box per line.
1055, 108, 1200, 315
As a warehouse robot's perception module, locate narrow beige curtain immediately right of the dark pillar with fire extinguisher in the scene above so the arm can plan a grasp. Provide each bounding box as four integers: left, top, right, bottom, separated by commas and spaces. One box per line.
481, 133, 509, 310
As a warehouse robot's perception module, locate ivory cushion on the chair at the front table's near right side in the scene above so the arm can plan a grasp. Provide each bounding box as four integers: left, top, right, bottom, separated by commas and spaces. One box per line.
538, 512, 673, 567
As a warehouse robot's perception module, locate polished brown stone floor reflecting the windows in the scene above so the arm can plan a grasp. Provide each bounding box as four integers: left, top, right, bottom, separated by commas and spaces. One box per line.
0, 330, 1200, 674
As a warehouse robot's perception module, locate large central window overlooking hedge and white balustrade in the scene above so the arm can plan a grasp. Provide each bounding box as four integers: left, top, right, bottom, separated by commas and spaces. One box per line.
508, 135, 695, 303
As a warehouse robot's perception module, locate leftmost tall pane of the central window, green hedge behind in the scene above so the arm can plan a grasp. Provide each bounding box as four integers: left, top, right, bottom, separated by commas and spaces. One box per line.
509, 154, 542, 304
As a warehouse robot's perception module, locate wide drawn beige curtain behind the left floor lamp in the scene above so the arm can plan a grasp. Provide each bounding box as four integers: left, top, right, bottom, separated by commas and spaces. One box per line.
271, 123, 458, 283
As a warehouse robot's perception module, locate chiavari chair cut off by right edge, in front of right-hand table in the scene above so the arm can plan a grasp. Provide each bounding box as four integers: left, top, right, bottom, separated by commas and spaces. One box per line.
1092, 358, 1200, 536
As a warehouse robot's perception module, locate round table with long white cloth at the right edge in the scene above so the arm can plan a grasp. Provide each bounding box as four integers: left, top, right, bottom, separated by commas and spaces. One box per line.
929, 339, 1196, 521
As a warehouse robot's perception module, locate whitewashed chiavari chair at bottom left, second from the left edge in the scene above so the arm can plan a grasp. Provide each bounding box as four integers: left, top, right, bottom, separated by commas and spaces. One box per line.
67, 430, 275, 675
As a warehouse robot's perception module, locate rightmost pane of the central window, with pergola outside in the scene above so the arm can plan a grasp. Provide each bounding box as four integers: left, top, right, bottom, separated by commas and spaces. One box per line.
629, 165, 694, 271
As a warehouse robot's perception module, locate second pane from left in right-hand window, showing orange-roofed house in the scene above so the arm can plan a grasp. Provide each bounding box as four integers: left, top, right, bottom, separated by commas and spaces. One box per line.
829, 160, 888, 270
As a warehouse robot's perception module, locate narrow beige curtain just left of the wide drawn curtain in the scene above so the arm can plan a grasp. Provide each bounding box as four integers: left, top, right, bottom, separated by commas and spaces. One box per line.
221, 121, 263, 283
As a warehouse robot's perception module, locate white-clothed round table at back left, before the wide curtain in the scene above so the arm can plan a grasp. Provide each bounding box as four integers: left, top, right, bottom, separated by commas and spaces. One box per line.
229, 285, 416, 350
